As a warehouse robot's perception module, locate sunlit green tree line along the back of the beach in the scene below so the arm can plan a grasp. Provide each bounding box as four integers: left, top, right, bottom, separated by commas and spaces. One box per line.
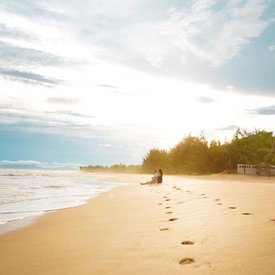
80, 128, 275, 175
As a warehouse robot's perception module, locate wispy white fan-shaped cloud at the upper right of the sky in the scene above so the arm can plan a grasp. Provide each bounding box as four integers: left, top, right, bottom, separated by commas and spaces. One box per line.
162, 0, 272, 66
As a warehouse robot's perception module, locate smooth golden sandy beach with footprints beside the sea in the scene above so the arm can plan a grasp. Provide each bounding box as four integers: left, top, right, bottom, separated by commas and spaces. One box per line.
0, 174, 275, 275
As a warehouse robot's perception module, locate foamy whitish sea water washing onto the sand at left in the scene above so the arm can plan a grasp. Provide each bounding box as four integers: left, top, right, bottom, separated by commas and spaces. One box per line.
0, 169, 115, 234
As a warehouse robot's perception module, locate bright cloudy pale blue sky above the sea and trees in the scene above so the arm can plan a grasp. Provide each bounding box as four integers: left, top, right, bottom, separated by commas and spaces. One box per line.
0, 0, 275, 167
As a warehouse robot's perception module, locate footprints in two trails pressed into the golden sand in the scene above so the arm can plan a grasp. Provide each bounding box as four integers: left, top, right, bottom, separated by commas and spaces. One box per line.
158, 185, 275, 265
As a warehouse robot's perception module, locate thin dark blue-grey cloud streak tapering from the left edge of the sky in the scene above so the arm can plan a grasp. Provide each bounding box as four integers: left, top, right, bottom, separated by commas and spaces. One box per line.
0, 68, 64, 85
